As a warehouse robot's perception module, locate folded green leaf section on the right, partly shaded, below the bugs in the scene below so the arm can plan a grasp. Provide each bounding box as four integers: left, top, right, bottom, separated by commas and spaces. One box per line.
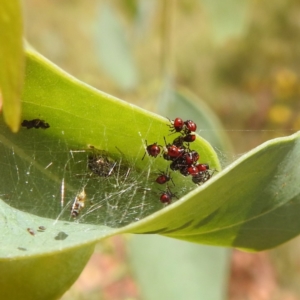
128, 132, 300, 251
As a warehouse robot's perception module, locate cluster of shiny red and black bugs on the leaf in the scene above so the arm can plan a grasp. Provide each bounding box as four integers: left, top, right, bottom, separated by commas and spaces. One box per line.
142, 118, 212, 204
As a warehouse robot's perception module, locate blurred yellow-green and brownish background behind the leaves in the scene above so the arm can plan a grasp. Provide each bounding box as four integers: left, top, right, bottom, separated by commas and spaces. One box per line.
23, 0, 300, 300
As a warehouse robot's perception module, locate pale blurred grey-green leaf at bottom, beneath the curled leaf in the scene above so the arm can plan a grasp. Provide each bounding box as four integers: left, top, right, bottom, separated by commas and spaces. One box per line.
128, 235, 230, 300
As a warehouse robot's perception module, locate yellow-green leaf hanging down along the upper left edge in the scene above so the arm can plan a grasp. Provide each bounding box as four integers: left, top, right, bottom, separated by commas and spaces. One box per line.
0, 0, 24, 132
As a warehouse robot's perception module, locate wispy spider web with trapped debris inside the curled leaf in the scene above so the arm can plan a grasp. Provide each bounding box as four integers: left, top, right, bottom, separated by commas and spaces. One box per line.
0, 120, 197, 227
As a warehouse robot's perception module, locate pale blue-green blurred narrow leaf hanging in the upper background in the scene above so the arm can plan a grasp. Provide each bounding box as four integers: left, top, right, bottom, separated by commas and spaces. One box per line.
94, 3, 138, 90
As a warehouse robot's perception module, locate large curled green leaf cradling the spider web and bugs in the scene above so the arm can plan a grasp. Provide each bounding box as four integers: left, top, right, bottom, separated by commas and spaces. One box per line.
0, 51, 219, 299
